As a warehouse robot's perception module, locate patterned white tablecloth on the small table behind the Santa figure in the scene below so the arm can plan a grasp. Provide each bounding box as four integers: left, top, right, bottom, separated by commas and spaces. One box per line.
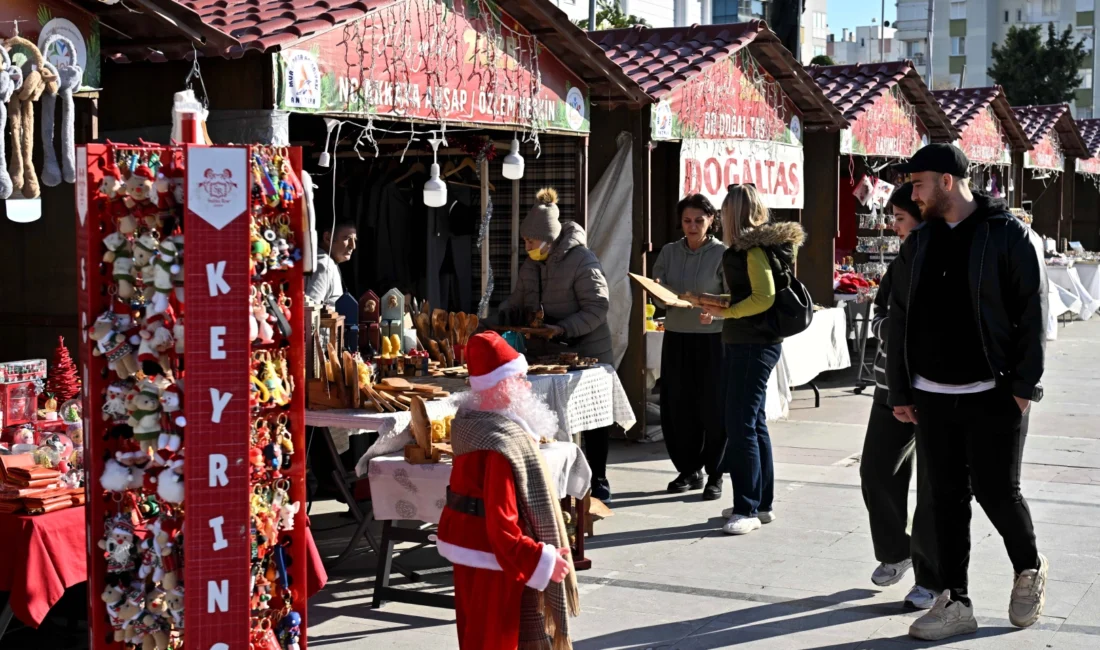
367, 442, 592, 524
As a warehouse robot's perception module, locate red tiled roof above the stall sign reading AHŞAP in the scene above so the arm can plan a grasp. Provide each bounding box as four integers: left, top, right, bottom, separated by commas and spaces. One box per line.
92, 0, 647, 103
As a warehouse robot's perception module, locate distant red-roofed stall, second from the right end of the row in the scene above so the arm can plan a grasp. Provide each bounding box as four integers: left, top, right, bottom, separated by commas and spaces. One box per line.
1012, 103, 1091, 246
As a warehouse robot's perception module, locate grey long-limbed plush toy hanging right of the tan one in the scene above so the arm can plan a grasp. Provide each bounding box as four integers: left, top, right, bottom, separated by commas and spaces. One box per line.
42, 34, 84, 187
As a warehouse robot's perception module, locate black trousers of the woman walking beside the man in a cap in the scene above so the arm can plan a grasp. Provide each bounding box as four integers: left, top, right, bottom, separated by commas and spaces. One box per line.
859, 401, 943, 592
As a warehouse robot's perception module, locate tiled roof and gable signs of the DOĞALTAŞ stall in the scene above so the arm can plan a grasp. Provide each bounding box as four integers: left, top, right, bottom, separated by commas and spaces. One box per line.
591, 21, 847, 209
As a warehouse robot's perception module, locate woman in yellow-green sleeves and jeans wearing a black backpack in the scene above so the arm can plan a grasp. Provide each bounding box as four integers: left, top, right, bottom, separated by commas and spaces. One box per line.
707, 185, 805, 535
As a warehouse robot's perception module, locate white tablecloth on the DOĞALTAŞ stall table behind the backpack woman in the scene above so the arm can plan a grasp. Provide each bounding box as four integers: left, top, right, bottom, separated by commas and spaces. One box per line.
646, 307, 851, 420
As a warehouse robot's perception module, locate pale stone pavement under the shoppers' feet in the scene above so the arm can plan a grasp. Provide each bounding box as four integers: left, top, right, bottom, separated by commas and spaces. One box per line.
309, 321, 1100, 650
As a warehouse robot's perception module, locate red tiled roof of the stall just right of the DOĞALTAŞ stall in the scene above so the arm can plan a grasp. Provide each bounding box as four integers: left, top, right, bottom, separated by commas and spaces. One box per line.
806, 60, 958, 142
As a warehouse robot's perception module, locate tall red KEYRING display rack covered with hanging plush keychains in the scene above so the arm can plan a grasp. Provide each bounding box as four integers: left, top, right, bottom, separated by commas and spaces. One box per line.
76, 143, 308, 650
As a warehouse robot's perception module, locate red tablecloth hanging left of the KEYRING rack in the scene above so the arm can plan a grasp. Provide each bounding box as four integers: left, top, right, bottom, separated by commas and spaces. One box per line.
0, 506, 88, 627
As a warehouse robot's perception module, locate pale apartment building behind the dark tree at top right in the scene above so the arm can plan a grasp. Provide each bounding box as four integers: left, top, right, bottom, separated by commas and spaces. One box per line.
932, 0, 1100, 119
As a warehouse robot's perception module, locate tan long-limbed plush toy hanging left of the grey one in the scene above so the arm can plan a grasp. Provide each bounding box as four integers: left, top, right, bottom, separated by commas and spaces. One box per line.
6, 36, 48, 199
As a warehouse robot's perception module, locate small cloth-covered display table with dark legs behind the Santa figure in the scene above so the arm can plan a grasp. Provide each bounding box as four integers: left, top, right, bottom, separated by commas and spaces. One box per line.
367, 441, 592, 608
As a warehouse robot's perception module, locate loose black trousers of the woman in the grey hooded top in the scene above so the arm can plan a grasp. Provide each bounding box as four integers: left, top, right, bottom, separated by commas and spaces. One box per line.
661, 332, 726, 475
